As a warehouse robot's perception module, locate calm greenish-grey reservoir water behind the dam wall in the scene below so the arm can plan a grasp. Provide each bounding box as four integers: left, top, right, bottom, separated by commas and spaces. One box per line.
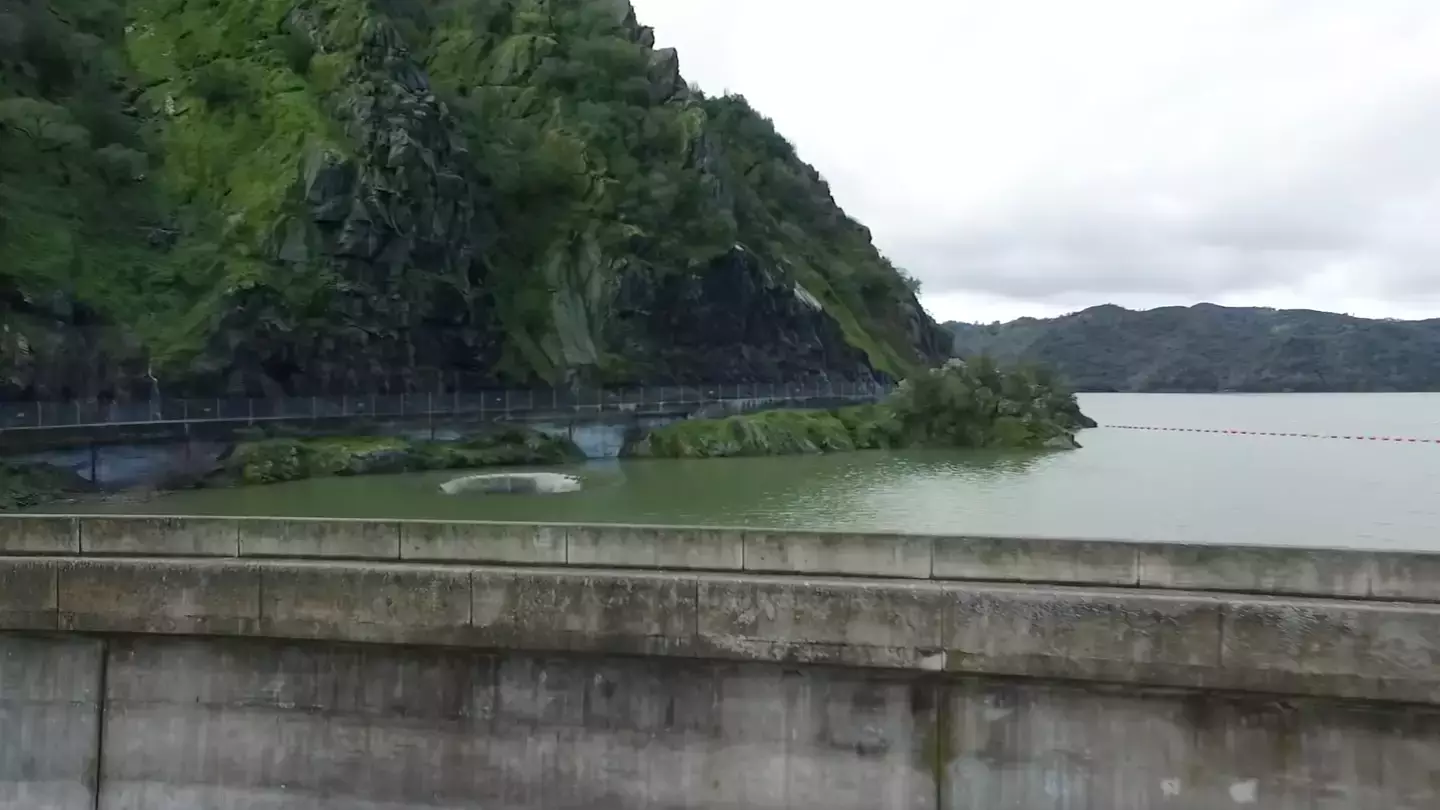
53, 393, 1440, 549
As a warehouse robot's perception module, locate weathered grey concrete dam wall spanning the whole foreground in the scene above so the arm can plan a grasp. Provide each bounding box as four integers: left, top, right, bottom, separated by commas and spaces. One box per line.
0, 517, 1440, 810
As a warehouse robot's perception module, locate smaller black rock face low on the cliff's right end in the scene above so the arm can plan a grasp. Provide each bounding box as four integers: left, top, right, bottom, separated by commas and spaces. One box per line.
616, 248, 876, 383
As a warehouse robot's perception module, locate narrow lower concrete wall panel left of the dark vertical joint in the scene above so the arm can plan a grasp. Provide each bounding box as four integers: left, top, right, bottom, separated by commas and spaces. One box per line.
0, 634, 102, 810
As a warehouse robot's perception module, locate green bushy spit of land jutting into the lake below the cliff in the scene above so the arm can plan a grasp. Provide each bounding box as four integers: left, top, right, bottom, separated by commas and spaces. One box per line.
626, 357, 1094, 458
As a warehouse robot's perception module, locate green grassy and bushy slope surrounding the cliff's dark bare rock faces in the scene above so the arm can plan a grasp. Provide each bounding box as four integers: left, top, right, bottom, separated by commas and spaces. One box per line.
0, 0, 938, 389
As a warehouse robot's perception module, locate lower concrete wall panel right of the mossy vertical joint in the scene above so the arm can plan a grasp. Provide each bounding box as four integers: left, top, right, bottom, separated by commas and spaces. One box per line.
943, 679, 1440, 810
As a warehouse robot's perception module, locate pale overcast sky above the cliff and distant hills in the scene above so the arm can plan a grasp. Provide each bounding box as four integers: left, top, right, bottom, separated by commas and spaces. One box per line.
632, 0, 1440, 321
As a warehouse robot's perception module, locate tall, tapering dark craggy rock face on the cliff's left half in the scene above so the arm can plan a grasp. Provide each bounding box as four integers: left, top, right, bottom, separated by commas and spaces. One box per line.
203, 26, 503, 395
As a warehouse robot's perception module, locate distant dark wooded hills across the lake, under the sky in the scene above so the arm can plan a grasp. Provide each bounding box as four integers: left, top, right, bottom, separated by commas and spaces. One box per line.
945, 304, 1440, 392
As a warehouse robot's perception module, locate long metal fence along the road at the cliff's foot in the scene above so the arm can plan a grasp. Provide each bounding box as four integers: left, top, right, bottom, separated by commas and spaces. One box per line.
0, 380, 890, 430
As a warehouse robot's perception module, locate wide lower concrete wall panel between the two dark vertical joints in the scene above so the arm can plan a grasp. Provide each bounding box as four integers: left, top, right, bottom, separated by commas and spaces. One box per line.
101, 640, 937, 810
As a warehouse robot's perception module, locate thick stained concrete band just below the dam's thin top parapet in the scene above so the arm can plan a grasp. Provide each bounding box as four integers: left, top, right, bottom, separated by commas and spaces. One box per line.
8, 556, 1440, 705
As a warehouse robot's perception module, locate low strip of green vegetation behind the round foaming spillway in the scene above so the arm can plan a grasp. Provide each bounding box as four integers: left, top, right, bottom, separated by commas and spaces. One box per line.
210, 428, 582, 484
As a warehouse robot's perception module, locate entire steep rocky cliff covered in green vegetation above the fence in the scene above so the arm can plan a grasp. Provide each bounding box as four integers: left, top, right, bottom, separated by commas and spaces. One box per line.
0, 0, 949, 399
